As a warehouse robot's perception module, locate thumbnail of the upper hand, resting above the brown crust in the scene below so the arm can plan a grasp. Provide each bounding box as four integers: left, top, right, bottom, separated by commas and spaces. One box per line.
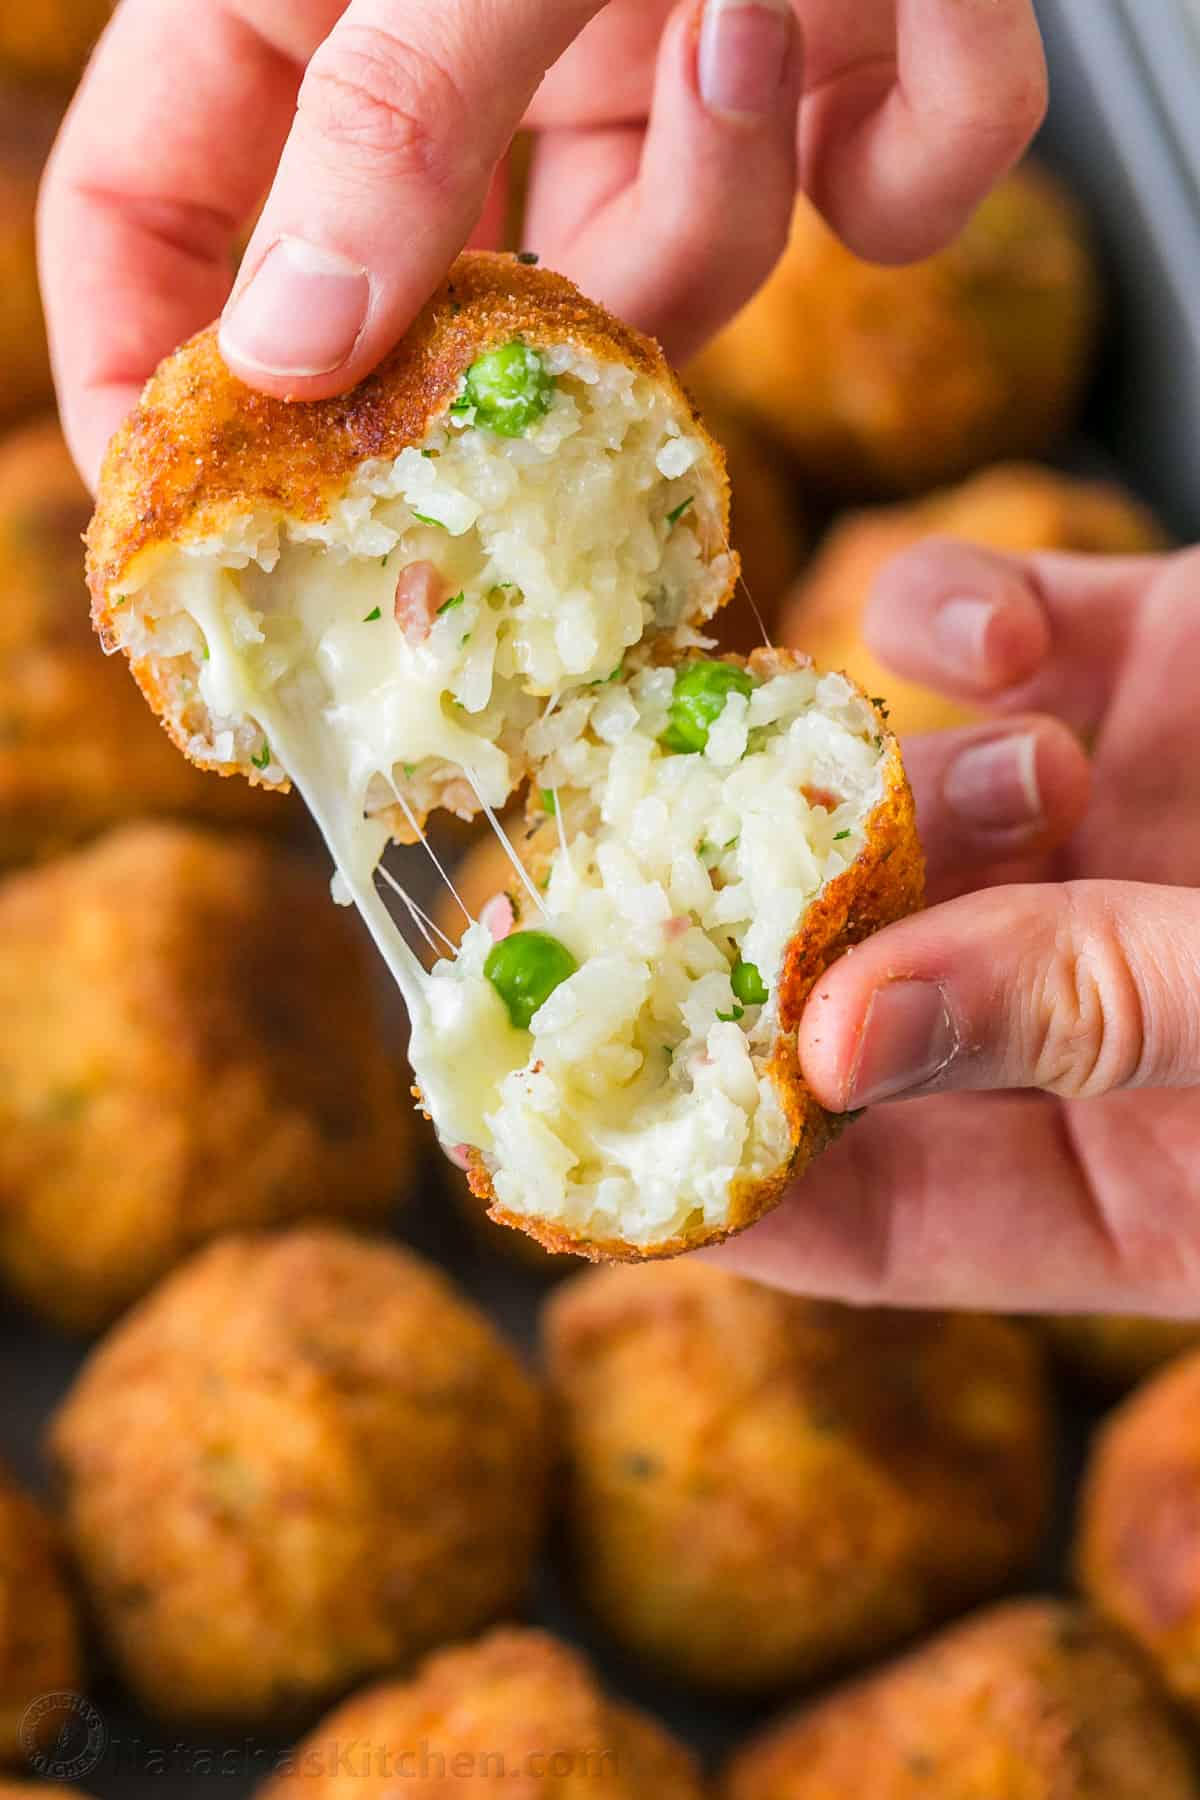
221, 238, 371, 376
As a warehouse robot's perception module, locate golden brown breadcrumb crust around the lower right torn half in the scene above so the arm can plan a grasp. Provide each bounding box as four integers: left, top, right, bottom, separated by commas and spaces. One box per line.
464, 650, 925, 1262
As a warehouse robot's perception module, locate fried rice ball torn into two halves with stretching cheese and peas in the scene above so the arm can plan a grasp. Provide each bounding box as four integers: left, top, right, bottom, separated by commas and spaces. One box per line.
90, 256, 921, 1256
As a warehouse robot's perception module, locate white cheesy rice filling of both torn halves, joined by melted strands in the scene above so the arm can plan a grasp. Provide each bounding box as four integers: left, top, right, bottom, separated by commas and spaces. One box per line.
100, 347, 885, 1246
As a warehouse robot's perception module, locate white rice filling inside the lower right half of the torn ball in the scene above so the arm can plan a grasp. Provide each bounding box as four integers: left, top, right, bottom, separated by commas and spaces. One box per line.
414, 670, 885, 1246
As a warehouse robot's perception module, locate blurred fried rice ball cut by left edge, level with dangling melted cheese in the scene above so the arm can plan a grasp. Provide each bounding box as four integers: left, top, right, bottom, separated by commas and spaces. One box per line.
0, 823, 412, 1330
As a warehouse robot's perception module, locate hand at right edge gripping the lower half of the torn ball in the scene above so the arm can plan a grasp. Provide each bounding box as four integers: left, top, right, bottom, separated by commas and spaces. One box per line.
716, 544, 1200, 1316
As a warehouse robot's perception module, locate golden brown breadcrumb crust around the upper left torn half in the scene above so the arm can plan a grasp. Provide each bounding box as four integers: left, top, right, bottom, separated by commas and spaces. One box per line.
88, 252, 736, 788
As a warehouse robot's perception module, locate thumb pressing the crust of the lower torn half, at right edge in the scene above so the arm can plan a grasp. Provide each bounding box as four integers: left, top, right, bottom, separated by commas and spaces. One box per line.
799, 882, 1200, 1112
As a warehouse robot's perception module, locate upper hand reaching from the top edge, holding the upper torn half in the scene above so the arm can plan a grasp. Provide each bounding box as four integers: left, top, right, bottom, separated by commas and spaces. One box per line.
41, 0, 1045, 481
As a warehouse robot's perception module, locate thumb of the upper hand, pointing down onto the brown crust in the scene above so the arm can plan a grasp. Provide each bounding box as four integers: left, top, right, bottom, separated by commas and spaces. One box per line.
221, 0, 603, 400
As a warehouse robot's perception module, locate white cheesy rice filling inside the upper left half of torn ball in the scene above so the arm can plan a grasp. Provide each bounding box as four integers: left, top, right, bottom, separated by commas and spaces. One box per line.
105, 346, 730, 835
